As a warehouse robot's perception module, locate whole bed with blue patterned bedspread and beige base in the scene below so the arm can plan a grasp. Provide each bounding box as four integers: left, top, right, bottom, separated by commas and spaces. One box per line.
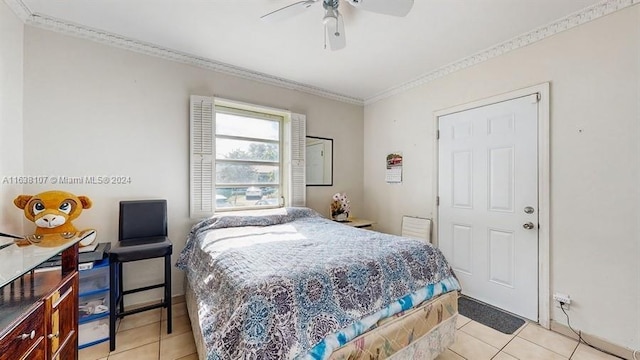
176, 208, 460, 360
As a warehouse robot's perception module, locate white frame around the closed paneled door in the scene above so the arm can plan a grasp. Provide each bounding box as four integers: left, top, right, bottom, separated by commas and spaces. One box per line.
432, 82, 551, 329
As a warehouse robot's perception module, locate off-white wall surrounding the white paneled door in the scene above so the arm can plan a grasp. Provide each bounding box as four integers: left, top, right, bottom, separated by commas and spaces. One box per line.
364, 6, 640, 348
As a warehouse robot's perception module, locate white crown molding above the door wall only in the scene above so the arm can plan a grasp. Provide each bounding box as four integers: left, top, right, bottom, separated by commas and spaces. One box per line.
364, 0, 640, 105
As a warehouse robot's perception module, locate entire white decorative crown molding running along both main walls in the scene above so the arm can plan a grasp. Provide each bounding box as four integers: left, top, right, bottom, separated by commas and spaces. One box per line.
4, 0, 640, 106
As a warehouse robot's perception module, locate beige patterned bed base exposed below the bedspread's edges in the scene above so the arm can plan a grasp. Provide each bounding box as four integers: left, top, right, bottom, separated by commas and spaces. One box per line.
185, 281, 458, 360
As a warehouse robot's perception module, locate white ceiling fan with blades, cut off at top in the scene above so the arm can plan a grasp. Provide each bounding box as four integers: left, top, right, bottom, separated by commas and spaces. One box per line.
260, 0, 413, 50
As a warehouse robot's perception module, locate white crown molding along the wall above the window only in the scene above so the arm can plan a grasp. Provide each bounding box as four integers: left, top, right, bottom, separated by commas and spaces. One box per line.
5, 0, 364, 106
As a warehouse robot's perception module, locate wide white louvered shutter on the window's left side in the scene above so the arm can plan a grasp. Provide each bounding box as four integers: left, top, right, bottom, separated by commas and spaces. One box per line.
190, 95, 215, 218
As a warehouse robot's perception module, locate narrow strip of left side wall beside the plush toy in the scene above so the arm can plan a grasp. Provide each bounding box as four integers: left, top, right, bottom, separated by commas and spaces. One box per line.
0, 1, 24, 234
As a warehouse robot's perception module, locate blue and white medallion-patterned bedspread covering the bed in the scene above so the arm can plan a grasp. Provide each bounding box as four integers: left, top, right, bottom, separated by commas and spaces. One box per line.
176, 208, 459, 360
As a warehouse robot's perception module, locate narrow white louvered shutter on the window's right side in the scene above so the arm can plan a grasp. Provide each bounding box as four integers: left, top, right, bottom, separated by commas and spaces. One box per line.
290, 113, 307, 206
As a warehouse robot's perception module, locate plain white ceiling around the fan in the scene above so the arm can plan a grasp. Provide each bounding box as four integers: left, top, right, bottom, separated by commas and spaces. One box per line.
13, 0, 601, 101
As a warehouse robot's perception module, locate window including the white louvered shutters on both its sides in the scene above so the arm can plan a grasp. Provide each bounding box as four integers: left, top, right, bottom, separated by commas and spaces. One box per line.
190, 95, 306, 218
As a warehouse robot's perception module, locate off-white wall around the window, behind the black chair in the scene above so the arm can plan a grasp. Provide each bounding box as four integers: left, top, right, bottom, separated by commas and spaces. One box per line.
24, 26, 363, 302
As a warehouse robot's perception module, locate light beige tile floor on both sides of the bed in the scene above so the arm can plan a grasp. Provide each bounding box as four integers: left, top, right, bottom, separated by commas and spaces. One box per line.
79, 302, 615, 360
